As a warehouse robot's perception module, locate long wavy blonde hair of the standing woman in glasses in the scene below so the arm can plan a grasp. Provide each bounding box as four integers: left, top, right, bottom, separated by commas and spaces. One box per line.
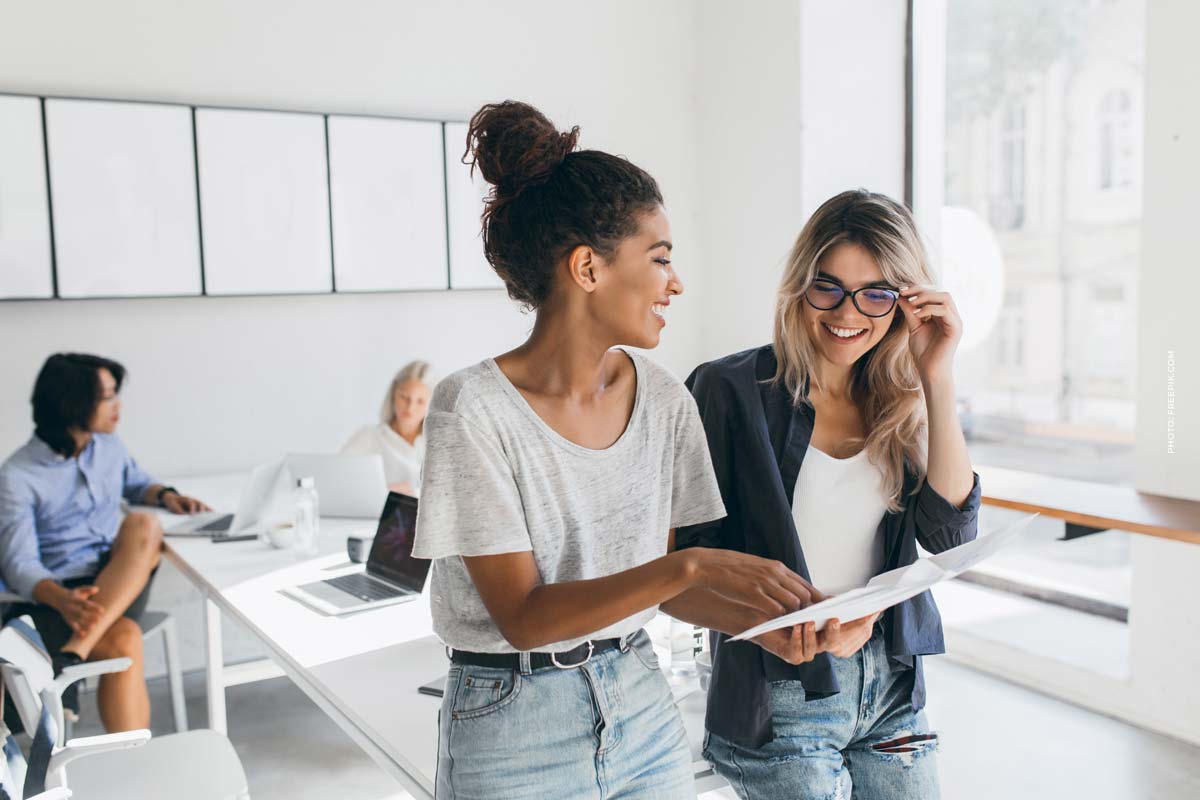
774, 190, 934, 511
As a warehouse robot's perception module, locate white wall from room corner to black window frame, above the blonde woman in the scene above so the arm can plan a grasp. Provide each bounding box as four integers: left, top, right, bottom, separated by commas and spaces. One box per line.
697, 0, 906, 360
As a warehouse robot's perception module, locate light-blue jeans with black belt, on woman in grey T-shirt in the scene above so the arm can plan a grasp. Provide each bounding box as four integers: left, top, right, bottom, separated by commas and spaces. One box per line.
434, 631, 696, 800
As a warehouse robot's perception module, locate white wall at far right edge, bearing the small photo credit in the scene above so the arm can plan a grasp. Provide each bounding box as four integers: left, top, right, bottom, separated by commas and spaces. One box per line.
1133, 0, 1200, 744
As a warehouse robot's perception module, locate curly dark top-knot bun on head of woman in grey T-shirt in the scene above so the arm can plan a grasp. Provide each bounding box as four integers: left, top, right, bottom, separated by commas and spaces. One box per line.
463, 100, 580, 197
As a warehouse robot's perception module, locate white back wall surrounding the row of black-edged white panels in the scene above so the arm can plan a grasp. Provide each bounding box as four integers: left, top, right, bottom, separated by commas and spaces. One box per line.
0, 0, 701, 475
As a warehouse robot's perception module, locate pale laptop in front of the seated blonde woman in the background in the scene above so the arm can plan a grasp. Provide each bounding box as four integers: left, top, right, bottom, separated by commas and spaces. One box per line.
287, 453, 388, 519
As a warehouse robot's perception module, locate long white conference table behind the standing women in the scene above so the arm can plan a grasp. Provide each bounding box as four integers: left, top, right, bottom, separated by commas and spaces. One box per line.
164, 475, 725, 798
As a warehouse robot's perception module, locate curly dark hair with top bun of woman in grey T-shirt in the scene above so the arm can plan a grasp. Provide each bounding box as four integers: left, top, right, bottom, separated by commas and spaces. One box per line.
463, 100, 662, 308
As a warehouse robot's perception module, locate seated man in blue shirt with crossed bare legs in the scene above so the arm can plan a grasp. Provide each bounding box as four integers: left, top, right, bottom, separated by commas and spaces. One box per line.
0, 354, 208, 732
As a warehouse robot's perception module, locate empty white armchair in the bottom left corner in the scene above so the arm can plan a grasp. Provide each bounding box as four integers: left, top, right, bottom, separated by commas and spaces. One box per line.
0, 616, 250, 800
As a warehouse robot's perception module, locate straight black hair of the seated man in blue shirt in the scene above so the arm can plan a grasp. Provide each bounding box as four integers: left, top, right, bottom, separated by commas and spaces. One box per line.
30, 353, 125, 457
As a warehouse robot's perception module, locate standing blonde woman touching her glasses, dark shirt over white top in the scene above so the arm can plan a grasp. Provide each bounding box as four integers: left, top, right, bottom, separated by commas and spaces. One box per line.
672, 191, 979, 800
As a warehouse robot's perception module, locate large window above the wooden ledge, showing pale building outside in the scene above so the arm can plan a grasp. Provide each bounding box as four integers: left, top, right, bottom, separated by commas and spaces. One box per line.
910, 0, 1146, 485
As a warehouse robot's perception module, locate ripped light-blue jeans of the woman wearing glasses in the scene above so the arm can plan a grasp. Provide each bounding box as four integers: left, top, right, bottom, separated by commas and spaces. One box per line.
704, 626, 938, 800
